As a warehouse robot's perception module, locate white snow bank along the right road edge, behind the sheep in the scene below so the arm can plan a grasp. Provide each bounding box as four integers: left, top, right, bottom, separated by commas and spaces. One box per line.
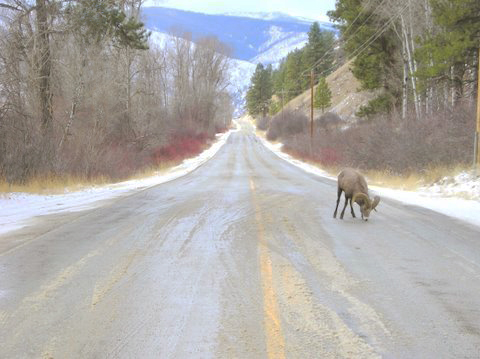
260, 134, 480, 226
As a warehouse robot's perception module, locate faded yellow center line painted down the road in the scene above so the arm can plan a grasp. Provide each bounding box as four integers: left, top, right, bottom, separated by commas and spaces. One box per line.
250, 178, 285, 359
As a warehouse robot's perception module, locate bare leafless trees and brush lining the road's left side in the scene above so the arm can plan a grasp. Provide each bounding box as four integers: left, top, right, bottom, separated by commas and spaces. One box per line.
0, 0, 232, 183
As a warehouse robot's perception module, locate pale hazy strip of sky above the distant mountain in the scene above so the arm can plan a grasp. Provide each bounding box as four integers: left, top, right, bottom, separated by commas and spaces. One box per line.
145, 0, 335, 20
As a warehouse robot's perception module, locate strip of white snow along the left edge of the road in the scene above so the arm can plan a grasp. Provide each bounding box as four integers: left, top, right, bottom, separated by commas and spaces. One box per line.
0, 130, 237, 234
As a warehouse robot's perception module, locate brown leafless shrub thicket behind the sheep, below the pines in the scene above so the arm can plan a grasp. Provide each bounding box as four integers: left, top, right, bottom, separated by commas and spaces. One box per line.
284, 103, 475, 175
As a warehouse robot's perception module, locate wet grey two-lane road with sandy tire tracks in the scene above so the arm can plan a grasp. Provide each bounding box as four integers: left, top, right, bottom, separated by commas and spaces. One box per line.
0, 119, 480, 358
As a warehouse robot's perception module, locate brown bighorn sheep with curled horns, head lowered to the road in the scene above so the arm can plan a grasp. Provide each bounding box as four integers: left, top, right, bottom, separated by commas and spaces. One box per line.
333, 168, 380, 221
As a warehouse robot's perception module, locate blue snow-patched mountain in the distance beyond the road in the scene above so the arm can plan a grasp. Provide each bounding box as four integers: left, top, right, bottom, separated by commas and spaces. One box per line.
142, 7, 336, 114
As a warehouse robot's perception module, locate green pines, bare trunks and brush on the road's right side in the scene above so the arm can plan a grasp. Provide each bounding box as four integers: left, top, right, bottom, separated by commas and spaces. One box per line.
247, 0, 480, 174
